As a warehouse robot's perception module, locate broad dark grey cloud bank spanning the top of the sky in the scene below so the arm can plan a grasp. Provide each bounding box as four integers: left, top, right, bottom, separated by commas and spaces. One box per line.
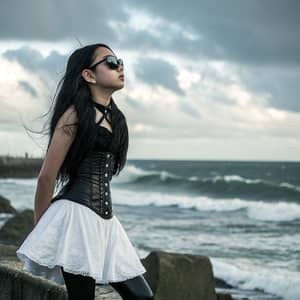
0, 0, 300, 65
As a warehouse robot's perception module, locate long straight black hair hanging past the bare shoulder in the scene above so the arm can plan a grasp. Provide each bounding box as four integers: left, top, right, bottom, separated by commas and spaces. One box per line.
42, 43, 128, 188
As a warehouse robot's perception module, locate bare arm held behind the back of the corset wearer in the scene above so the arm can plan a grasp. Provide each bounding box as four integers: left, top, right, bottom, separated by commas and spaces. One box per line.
34, 105, 77, 224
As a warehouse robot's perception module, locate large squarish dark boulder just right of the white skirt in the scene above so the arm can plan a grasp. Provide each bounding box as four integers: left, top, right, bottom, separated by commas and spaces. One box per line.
143, 251, 217, 300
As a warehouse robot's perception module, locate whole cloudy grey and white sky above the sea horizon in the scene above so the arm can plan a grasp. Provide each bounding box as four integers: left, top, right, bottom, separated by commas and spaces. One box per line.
0, 0, 300, 160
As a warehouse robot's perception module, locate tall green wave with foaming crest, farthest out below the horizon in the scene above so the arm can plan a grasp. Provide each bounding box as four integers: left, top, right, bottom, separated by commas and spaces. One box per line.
115, 165, 300, 203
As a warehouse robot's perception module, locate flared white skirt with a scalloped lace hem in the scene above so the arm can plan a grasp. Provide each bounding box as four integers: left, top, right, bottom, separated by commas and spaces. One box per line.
16, 199, 146, 284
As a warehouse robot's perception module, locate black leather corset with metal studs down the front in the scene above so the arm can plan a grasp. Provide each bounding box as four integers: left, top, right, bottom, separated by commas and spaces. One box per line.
51, 125, 115, 219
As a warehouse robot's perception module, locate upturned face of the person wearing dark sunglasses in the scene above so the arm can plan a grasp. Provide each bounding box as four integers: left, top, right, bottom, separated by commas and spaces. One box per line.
91, 47, 124, 90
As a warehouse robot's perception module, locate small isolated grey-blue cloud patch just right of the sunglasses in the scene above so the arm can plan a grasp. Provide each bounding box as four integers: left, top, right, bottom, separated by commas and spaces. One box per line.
134, 58, 184, 94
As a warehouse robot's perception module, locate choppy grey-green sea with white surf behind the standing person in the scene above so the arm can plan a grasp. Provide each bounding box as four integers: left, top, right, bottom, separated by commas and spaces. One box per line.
0, 160, 300, 300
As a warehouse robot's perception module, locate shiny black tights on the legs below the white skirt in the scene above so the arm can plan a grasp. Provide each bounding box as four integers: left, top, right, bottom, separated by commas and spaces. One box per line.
61, 267, 153, 300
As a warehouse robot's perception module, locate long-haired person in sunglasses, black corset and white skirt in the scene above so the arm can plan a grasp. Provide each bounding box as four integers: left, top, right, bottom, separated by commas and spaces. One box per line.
16, 44, 153, 300
